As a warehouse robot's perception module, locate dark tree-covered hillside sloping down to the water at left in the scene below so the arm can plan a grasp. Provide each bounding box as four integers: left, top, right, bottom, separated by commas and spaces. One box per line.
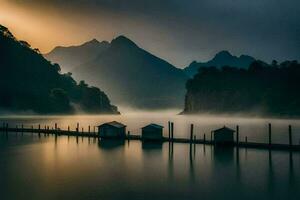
0, 25, 118, 114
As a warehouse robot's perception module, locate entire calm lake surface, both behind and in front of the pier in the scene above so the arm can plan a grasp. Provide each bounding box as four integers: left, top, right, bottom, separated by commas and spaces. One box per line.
0, 113, 300, 199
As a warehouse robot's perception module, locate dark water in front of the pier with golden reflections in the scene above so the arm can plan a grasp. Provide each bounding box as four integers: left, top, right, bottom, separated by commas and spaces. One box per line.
0, 133, 300, 200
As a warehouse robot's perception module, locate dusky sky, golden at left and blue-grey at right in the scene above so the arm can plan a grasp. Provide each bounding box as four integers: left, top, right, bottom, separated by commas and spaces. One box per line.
0, 0, 300, 67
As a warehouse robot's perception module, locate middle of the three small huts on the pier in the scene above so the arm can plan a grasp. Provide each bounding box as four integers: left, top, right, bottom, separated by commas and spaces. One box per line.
142, 124, 164, 141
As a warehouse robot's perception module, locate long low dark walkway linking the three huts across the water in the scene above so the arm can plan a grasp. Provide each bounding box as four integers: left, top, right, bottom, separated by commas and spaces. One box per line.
0, 124, 300, 151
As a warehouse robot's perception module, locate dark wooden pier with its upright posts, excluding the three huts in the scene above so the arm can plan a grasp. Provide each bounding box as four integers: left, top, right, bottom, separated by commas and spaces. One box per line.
0, 122, 300, 151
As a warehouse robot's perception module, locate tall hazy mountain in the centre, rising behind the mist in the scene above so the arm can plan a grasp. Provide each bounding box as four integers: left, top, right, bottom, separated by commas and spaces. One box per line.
46, 36, 187, 108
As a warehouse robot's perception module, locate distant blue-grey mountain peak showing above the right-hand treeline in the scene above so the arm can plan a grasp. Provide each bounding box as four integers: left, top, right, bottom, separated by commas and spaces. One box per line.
184, 51, 255, 77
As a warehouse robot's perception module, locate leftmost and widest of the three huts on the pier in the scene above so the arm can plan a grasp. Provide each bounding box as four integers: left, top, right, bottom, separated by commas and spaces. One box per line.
98, 121, 126, 139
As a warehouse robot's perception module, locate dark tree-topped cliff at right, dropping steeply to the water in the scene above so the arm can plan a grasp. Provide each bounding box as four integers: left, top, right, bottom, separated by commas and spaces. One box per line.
184, 61, 300, 116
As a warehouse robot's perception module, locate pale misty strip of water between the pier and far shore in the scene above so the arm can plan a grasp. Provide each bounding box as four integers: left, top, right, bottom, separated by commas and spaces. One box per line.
0, 108, 300, 144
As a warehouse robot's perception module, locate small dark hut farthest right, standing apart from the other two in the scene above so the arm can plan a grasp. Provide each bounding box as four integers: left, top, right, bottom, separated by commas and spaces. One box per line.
212, 126, 235, 145
